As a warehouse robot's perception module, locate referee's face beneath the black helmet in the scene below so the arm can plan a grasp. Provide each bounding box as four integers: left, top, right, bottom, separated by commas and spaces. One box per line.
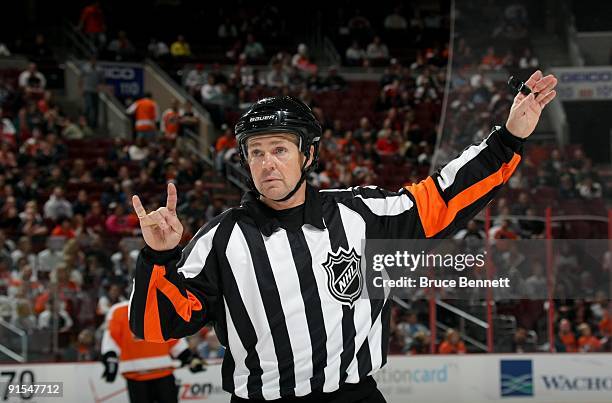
247, 133, 305, 204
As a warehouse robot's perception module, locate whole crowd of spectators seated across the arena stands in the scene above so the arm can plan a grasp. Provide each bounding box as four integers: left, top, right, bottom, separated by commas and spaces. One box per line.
0, 1, 612, 360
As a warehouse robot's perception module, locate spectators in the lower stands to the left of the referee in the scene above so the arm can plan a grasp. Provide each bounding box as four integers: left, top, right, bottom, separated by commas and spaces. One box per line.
0, 64, 232, 360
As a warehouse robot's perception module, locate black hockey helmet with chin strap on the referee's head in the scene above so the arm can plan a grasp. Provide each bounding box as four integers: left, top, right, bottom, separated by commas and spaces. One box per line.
234, 96, 322, 201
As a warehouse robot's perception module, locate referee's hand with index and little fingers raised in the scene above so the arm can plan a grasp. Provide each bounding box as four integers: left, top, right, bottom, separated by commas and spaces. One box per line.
132, 183, 183, 251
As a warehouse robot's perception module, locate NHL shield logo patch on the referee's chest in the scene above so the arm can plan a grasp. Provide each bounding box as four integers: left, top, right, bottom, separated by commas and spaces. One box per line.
323, 248, 363, 308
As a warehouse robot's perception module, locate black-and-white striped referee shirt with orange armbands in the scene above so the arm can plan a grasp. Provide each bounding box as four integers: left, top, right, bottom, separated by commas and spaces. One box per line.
130, 127, 523, 400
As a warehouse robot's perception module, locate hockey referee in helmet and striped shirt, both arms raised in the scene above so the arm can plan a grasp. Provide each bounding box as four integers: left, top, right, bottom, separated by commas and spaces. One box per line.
130, 71, 557, 403
